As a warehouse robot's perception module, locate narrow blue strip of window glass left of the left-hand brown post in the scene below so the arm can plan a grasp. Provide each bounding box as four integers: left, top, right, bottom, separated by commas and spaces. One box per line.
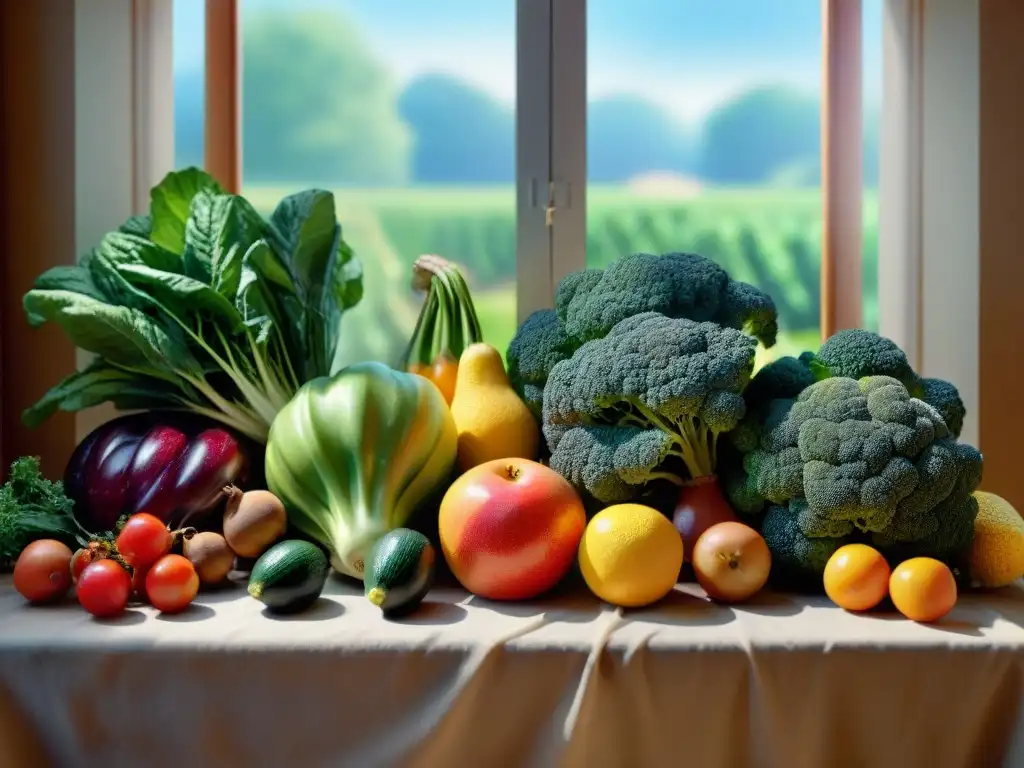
171, 0, 206, 168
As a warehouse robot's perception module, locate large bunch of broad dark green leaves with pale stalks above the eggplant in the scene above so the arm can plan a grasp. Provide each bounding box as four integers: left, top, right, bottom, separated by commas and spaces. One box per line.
23, 168, 362, 440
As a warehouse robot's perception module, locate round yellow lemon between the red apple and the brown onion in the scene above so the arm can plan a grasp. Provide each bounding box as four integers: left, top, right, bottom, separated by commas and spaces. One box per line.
580, 504, 683, 608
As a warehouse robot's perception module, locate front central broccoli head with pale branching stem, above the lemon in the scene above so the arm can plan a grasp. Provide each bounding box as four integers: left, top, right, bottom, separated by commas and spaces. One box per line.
543, 312, 757, 503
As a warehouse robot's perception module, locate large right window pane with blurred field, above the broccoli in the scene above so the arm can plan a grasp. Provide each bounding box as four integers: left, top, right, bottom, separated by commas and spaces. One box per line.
587, 0, 821, 360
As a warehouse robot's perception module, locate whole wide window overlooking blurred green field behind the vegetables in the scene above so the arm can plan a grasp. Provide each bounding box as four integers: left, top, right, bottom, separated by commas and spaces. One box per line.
175, 0, 883, 370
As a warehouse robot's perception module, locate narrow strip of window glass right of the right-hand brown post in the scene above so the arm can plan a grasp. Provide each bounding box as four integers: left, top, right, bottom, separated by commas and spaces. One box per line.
861, 0, 883, 332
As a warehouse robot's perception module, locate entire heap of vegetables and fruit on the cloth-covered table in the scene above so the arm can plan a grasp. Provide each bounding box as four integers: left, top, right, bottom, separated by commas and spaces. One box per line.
0, 169, 1024, 623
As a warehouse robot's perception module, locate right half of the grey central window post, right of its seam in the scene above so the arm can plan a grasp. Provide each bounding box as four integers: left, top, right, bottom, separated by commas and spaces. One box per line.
550, 0, 587, 288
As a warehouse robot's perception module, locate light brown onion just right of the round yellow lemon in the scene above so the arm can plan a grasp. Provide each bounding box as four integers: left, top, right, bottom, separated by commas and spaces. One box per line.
690, 521, 771, 603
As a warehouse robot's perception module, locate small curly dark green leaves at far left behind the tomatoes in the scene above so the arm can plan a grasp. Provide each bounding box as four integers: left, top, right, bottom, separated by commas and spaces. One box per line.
0, 456, 83, 571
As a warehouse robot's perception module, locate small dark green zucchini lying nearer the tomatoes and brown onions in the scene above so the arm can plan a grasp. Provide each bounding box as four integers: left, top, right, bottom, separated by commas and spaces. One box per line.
249, 540, 331, 613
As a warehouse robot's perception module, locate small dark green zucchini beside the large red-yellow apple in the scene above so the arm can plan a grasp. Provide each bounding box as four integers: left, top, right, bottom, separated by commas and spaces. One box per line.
362, 528, 437, 617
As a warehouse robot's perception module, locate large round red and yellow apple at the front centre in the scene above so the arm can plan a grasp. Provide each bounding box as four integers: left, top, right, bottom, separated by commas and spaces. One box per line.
438, 459, 587, 600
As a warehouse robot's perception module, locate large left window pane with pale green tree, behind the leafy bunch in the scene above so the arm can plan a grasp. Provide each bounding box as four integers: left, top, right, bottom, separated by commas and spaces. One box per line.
236, 0, 516, 370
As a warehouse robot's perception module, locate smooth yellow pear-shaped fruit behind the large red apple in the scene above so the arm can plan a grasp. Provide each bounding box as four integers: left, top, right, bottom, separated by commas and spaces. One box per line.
452, 343, 541, 472
